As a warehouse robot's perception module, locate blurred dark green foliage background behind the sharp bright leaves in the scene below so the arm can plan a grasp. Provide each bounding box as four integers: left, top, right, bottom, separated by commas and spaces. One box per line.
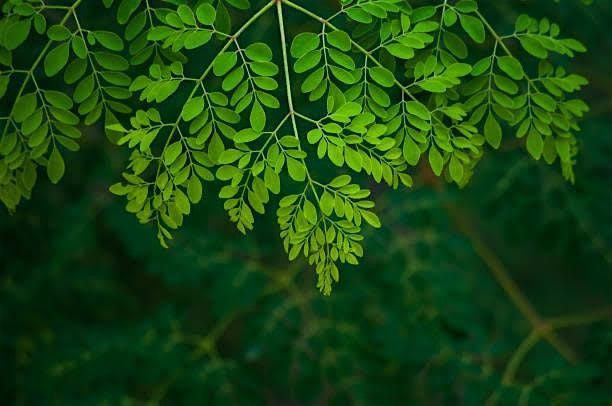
0, 0, 612, 405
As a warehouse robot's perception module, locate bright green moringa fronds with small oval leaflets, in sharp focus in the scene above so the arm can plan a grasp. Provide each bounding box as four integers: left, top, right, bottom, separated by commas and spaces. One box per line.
0, 0, 588, 294
